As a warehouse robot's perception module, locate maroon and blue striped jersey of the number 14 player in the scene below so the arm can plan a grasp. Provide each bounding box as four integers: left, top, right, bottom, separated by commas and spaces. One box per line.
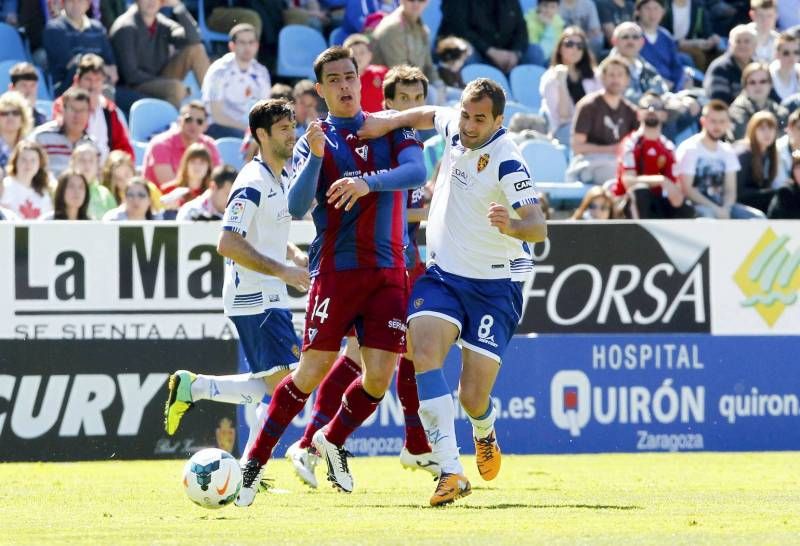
292, 113, 422, 275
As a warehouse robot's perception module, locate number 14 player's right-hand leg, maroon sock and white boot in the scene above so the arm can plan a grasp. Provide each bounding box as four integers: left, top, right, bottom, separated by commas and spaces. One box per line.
313, 347, 397, 493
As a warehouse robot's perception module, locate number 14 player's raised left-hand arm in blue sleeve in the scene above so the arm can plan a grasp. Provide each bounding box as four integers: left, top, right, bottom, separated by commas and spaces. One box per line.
287, 121, 325, 218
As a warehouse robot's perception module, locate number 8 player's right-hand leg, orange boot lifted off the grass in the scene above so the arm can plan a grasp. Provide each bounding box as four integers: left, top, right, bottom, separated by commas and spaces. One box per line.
458, 348, 500, 481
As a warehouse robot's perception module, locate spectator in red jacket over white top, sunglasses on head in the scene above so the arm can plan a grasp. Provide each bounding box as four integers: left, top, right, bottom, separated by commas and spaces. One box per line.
53, 53, 133, 161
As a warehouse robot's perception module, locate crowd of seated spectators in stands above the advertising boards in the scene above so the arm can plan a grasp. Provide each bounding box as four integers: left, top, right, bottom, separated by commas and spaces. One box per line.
0, 0, 800, 221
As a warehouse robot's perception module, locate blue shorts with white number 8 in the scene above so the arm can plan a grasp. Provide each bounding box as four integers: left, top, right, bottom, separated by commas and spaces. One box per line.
408, 265, 522, 362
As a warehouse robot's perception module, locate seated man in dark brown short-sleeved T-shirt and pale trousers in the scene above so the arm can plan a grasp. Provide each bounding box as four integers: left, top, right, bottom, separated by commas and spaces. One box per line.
567, 55, 637, 184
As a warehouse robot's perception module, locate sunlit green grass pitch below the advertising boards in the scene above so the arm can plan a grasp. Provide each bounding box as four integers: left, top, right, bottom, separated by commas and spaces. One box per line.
0, 452, 800, 546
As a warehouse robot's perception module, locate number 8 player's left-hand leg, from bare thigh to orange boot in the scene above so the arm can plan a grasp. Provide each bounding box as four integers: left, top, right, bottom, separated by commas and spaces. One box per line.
409, 315, 472, 506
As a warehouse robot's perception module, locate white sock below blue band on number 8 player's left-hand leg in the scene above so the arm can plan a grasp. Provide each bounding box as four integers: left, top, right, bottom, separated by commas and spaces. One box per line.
419, 394, 464, 474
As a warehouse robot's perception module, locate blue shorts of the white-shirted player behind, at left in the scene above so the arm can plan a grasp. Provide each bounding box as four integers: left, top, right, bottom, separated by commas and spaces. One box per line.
228, 309, 300, 377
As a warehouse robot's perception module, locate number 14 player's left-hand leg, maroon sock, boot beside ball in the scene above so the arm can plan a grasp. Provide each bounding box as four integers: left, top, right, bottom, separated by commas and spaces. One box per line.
236, 349, 338, 506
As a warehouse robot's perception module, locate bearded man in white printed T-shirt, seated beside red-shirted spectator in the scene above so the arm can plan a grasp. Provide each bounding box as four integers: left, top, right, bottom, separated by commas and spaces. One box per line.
676, 99, 763, 219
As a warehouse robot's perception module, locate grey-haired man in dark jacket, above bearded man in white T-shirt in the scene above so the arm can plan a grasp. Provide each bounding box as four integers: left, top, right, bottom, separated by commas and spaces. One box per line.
703, 25, 756, 104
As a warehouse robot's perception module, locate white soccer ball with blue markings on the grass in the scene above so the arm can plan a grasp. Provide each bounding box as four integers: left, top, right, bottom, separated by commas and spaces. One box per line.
183, 447, 242, 508
